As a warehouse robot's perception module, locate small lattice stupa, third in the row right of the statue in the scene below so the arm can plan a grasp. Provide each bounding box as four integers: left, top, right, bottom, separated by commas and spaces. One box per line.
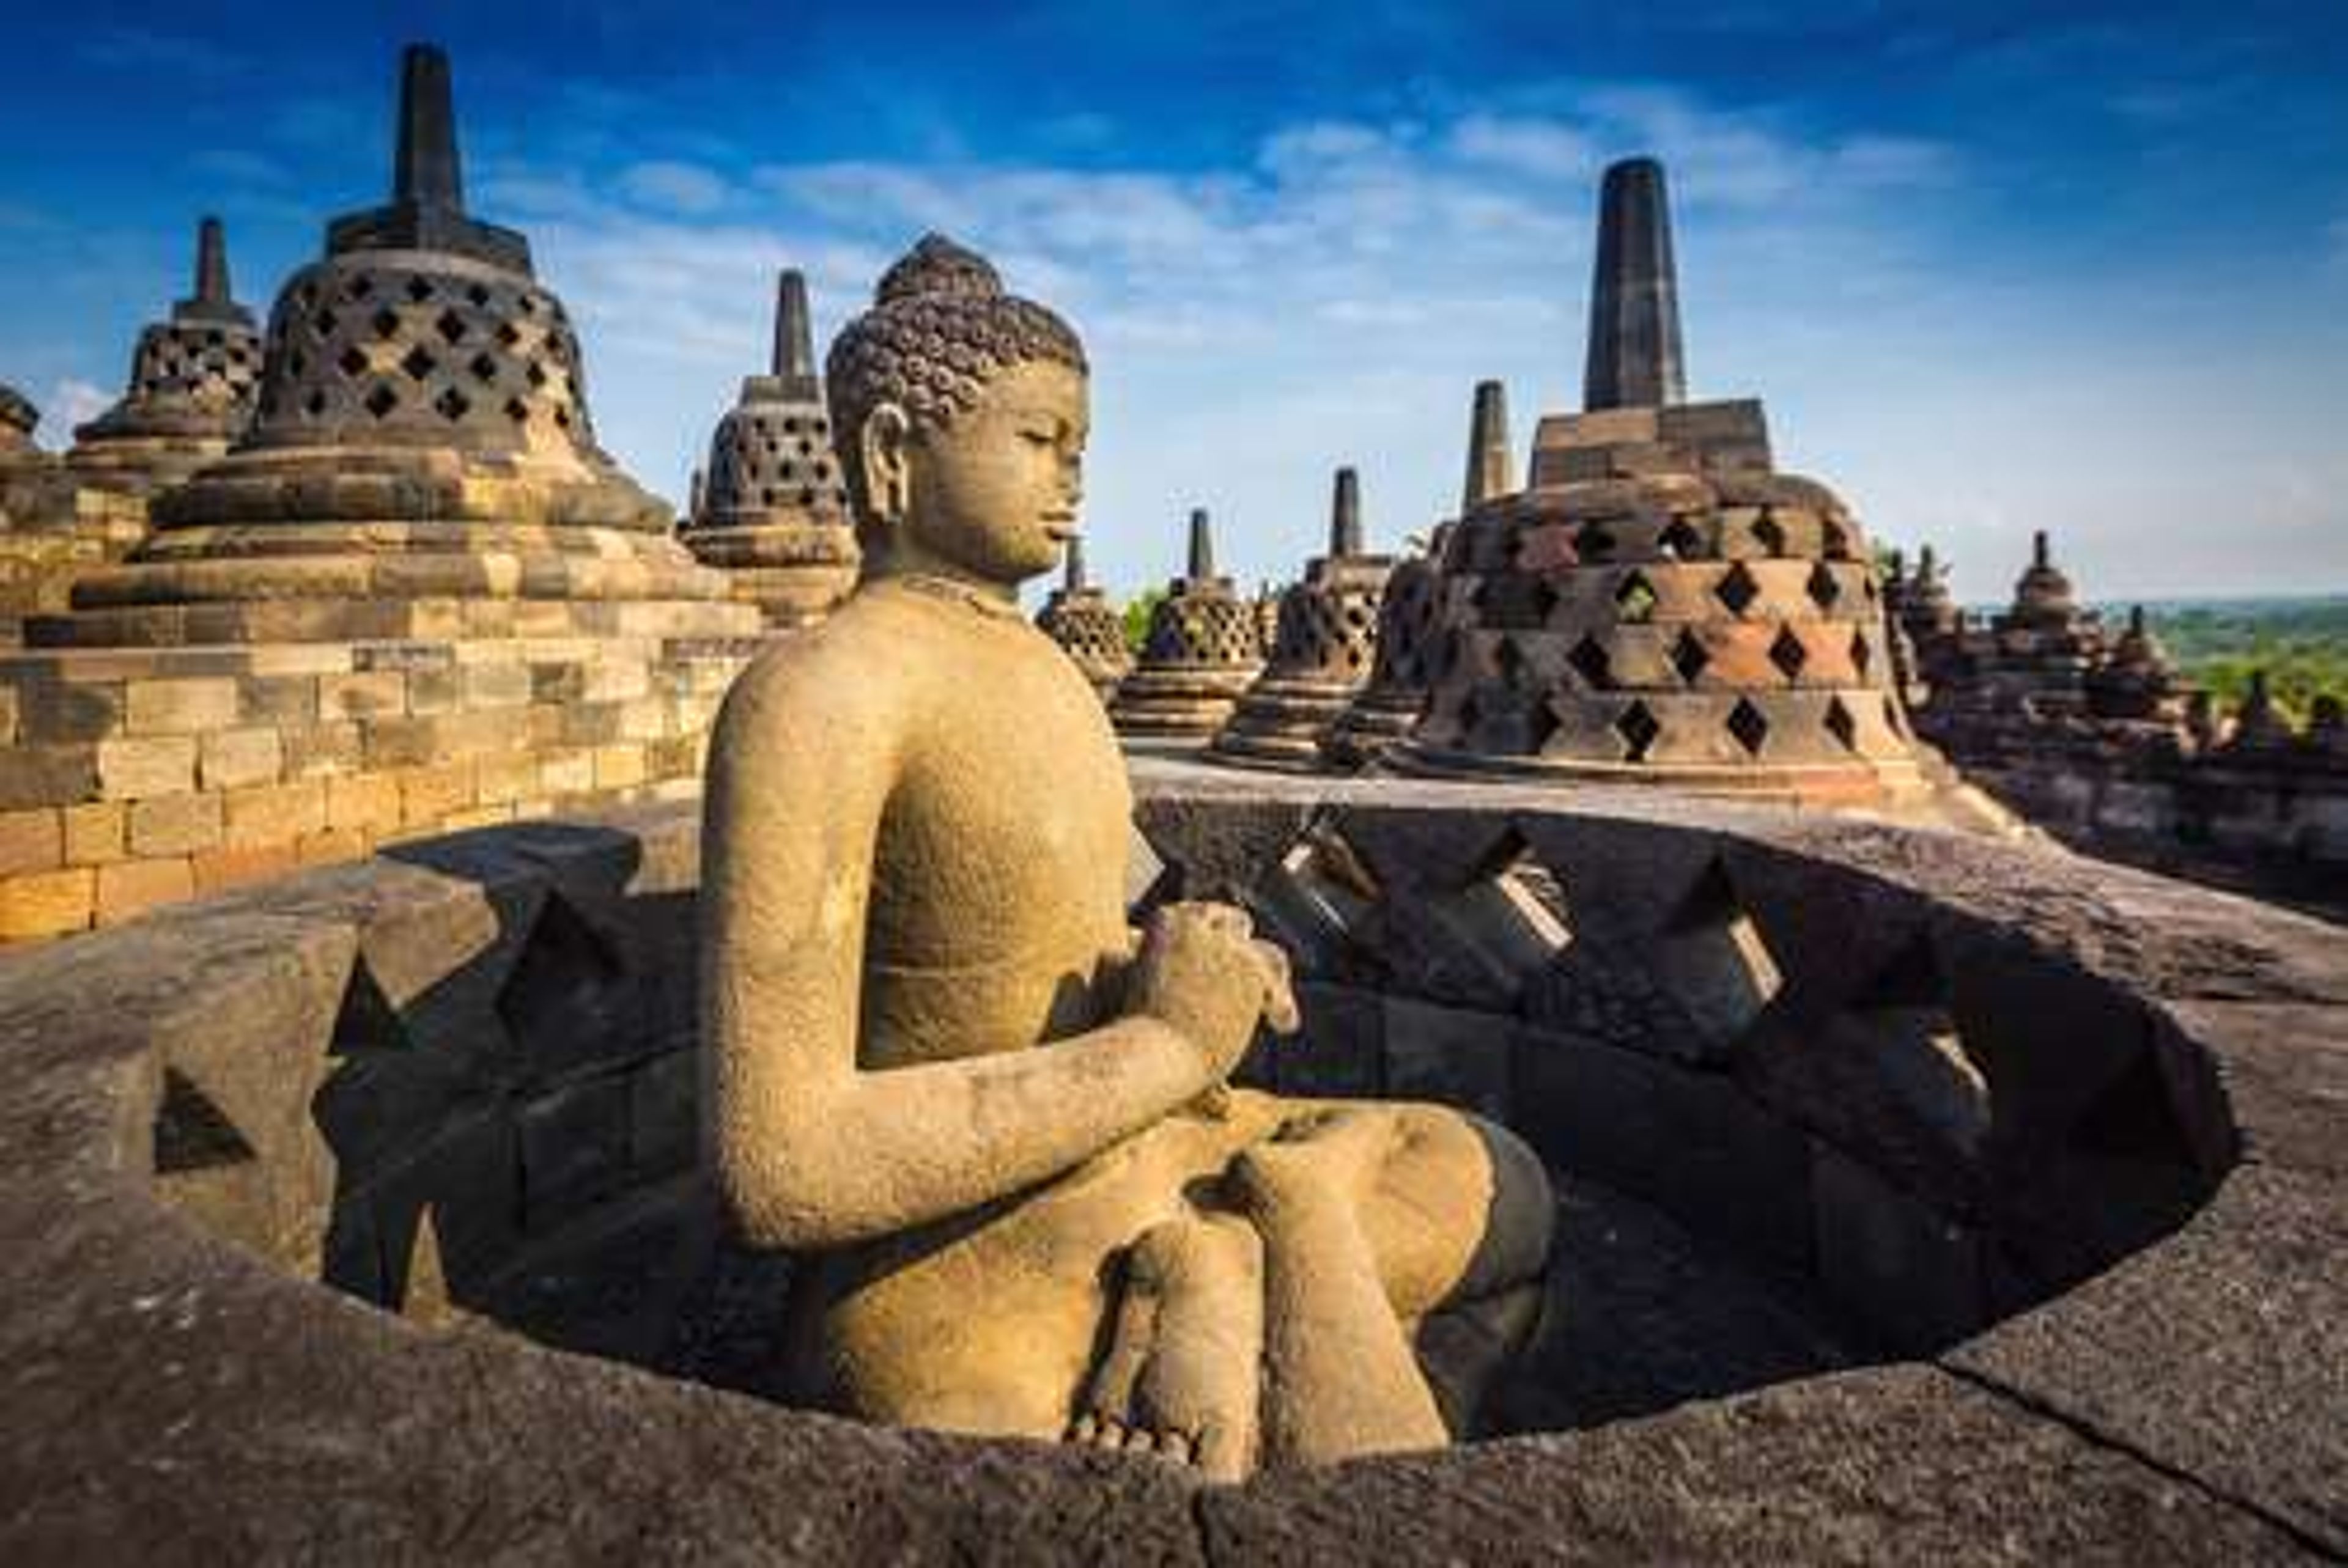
1209, 467, 1395, 772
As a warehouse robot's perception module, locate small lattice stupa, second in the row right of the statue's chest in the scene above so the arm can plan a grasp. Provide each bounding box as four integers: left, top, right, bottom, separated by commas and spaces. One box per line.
1108, 507, 1263, 740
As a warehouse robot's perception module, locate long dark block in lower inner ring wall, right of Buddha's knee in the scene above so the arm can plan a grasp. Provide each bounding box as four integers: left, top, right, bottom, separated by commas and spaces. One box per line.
1510, 1028, 1812, 1270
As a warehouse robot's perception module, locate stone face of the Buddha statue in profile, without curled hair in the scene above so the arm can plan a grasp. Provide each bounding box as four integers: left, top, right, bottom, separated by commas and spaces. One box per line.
897, 359, 1090, 584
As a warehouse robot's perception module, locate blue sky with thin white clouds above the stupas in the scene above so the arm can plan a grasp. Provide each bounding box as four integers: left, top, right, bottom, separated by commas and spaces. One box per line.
0, 0, 2348, 598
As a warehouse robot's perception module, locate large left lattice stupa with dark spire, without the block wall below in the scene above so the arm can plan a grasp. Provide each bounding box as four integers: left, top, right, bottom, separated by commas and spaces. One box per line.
47, 47, 735, 646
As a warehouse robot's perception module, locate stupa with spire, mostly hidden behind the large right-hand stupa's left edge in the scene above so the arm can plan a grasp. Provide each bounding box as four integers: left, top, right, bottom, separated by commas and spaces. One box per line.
1322, 380, 1515, 772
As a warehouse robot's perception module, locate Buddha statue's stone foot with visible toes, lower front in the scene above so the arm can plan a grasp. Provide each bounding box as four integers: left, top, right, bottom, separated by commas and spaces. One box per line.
1068, 1213, 1263, 1481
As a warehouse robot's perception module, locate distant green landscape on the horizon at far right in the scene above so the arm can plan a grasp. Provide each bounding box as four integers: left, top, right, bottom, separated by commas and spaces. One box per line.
2132, 596, 2348, 723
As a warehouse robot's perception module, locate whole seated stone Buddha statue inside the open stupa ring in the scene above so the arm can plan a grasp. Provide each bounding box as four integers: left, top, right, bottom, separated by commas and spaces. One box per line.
702, 237, 1552, 1481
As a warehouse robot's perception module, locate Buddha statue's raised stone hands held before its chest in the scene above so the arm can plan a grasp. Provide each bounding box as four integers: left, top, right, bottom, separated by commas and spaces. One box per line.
1124, 904, 1296, 1082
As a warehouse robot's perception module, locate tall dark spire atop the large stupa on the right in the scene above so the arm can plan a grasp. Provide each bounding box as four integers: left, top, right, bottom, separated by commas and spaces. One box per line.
1582, 157, 1688, 411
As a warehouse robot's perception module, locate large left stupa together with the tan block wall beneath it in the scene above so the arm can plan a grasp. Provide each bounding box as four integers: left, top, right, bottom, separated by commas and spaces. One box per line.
0, 47, 761, 939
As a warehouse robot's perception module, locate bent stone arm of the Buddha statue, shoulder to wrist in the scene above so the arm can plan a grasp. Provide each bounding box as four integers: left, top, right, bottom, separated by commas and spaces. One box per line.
702, 667, 1261, 1246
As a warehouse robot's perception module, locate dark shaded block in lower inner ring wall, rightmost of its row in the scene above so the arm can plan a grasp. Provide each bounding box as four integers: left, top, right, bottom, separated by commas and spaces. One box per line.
1811, 1143, 1987, 1356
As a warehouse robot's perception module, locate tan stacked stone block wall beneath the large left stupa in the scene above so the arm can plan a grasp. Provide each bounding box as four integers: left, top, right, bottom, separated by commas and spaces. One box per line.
0, 636, 754, 941
